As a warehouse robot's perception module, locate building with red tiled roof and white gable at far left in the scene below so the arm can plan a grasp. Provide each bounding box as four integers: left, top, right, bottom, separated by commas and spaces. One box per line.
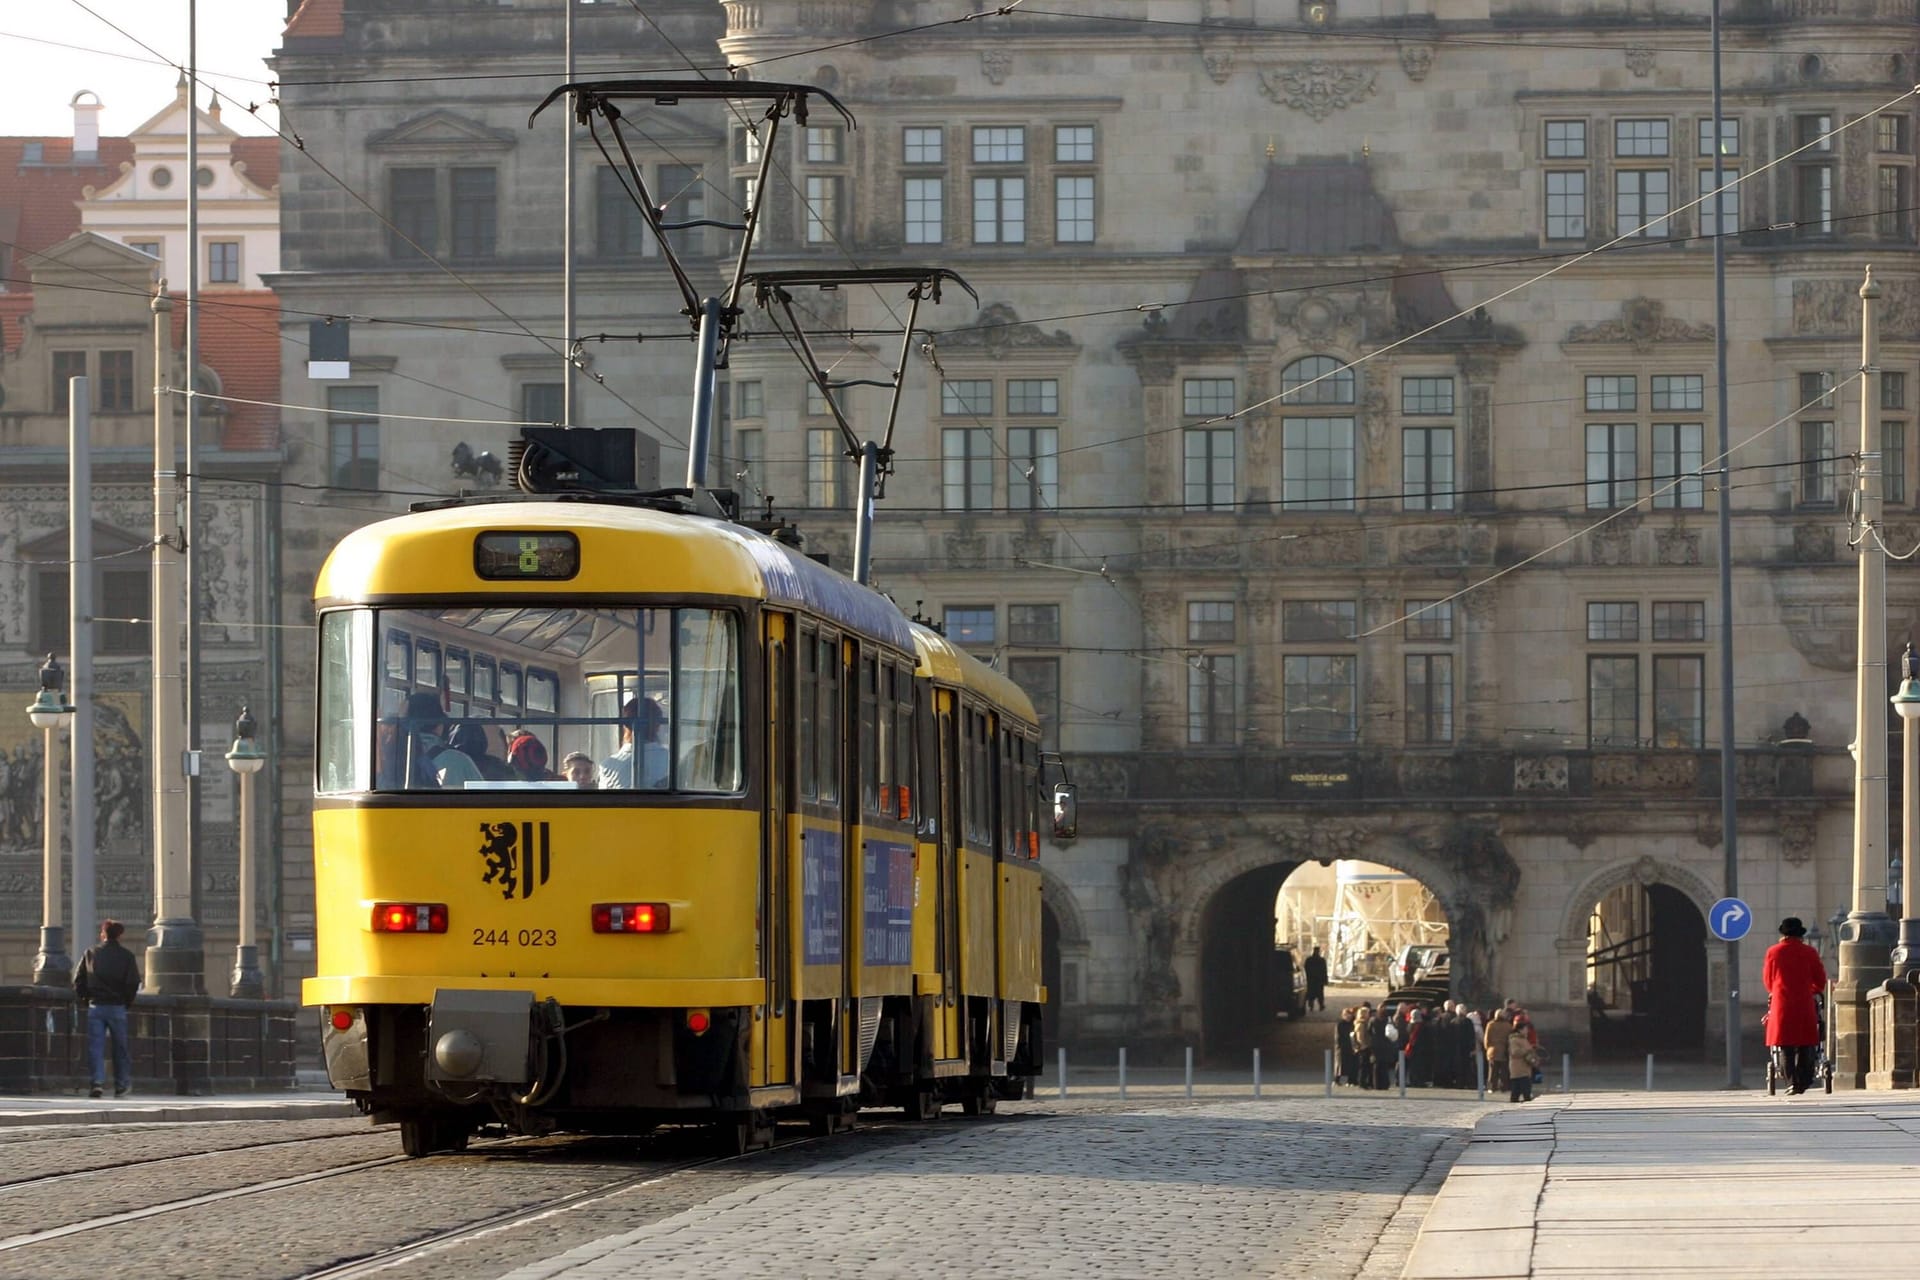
0, 94, 288, 994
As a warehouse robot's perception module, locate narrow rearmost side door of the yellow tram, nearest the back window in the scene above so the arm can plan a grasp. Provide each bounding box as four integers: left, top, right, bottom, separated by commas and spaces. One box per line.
753, 614, 801, 1084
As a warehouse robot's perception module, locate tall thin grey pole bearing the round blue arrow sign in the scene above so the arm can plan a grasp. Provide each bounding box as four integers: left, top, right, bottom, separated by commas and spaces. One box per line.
1711, 0, 1741, 1088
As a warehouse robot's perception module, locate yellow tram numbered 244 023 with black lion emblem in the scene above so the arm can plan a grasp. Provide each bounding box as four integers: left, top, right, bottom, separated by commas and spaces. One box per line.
303, 499, 1046, 1155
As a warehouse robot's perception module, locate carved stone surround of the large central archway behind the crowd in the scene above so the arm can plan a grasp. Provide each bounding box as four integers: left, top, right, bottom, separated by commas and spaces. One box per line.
1125, 818, 1521, 1040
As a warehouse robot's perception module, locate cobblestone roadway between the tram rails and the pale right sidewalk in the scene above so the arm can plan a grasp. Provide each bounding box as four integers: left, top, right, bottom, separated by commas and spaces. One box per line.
509, 1094, 1486, 1280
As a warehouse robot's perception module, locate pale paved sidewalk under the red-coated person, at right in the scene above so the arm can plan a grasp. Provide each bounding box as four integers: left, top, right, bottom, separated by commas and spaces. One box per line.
1404, 1090, 1920, 1280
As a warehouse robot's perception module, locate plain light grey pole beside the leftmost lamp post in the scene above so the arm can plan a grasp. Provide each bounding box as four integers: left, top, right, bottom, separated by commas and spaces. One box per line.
67, 378, 100, 946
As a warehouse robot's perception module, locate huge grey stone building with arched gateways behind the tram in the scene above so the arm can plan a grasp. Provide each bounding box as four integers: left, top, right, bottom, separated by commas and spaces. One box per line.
273, 0, 1920, 1050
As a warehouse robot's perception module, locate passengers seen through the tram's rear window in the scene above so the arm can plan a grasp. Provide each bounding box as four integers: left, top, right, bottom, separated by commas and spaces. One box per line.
382, 691, 666, 791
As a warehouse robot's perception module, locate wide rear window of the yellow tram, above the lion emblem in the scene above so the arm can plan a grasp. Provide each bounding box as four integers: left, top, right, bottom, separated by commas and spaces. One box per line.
317, 603, 743, 793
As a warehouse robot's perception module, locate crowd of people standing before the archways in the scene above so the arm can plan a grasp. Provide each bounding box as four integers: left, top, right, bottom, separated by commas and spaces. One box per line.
1334, 1000, 1544, 1102
